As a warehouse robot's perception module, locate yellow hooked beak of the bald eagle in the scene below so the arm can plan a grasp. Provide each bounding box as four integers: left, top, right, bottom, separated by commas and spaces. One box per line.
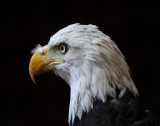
29, 45, 64, 83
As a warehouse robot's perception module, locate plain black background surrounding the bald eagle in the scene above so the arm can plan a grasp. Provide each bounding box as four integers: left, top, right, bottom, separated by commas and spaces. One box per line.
0, 0, 160, 126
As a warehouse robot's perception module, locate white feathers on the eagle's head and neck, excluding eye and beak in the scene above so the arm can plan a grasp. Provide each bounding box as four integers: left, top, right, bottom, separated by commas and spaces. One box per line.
48, 24, 138, 123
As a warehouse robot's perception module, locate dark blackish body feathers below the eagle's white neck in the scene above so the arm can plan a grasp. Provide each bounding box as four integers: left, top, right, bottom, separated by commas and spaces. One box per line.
73, 91, 160, 126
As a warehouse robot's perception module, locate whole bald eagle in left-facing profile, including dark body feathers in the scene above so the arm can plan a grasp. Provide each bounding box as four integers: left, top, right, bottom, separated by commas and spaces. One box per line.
29, 23, 160, 126
